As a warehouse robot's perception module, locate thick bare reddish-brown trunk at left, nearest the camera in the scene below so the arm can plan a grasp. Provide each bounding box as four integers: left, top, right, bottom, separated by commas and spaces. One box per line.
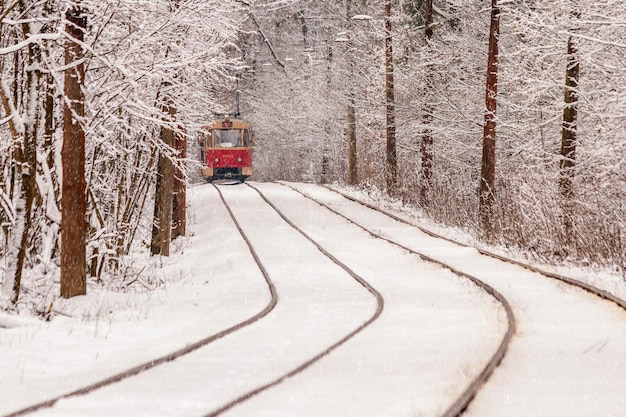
61, 5, 87, 298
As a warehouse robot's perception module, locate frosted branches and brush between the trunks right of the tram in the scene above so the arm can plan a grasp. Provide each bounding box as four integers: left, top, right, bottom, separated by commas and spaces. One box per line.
244, 0, 626, 264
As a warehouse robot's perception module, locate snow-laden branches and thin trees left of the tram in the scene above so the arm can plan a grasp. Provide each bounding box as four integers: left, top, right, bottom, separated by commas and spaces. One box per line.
0, 0, 248, 306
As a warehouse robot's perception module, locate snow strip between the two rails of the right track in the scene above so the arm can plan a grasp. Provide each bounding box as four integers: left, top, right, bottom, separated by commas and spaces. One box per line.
286, 184, 626, 417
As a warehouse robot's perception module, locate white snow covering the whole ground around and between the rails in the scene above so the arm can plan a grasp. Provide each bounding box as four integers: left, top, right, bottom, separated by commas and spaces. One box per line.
0, 184, 626, 416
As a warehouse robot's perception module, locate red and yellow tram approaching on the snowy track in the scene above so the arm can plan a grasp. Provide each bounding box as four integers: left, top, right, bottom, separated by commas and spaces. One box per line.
198, 116, 256, 182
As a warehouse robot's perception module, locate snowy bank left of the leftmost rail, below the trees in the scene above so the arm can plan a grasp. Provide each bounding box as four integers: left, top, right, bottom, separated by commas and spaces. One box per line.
0, 186, 270, 415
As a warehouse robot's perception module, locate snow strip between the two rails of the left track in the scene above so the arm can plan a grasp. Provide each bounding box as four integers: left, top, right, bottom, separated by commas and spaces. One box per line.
14, 186, 376, 416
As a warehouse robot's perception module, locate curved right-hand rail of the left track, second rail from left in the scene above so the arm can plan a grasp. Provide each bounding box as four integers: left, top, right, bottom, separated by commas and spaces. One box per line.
204, 184, 385, 417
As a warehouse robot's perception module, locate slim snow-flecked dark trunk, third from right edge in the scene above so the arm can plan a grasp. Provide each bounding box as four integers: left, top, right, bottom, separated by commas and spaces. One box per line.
420, 0, 433, 207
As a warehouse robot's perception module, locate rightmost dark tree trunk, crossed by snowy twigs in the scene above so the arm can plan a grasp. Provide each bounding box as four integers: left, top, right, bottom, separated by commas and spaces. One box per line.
559, 36, 580, 239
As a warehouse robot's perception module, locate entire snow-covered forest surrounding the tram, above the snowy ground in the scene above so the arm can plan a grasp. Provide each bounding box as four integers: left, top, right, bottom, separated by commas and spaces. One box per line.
0, 0, 626, 311
